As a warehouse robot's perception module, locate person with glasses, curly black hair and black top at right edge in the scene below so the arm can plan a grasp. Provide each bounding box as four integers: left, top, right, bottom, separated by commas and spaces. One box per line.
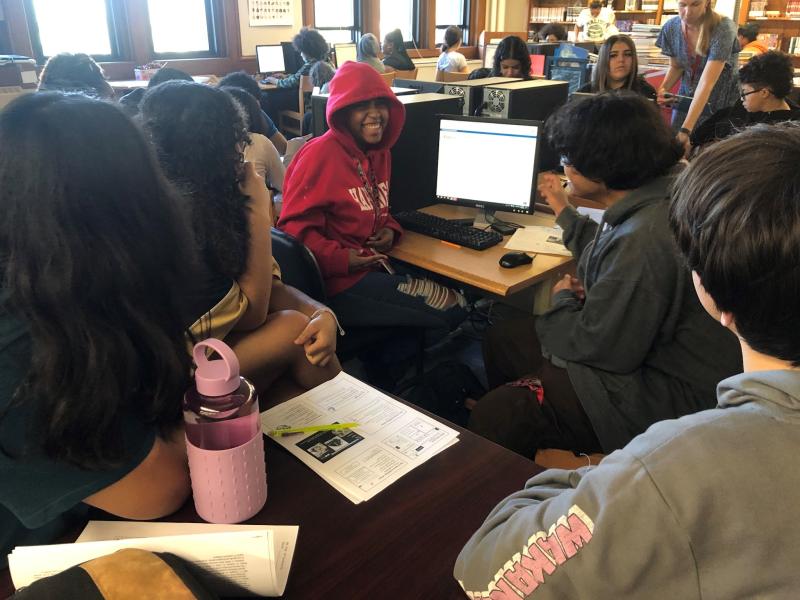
692, 50, 800, 146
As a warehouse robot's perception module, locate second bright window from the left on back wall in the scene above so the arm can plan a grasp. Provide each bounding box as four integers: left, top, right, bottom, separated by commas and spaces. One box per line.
147, 0, 218, 58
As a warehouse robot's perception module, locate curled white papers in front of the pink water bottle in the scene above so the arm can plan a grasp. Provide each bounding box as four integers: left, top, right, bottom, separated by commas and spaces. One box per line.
8, 521, 298, 596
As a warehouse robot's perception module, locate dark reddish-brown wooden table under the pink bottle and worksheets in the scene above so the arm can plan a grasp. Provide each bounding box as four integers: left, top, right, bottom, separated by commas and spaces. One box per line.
0, 406, 542, 600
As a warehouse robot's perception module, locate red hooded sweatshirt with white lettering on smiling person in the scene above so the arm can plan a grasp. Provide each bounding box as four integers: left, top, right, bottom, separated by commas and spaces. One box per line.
278, 62, 405, 296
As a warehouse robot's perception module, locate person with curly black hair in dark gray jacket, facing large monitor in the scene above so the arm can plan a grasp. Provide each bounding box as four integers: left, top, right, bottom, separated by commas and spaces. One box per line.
469, 92, 741, 457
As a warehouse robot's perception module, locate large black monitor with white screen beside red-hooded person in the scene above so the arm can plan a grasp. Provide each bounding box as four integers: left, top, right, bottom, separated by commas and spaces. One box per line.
436, 116, 542, 213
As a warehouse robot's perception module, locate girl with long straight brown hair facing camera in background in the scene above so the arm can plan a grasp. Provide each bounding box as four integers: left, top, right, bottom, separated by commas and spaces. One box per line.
580, 35, 656, 100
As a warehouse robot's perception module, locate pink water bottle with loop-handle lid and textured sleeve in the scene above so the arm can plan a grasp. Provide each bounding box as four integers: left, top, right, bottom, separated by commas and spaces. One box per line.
183, 338, 267, 523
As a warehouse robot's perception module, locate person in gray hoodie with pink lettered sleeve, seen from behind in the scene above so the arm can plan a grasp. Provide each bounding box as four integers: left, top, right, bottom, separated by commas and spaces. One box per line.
455, 124, 800, 600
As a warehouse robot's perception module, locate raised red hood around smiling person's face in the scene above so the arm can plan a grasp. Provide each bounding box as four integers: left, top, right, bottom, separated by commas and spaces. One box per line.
325, 61, 406, 150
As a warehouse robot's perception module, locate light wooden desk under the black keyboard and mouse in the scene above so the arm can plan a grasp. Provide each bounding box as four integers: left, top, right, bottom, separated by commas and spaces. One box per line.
389, 204, 573, 296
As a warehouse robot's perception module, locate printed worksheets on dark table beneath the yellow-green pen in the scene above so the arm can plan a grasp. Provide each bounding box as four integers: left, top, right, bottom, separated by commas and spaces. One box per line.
261, 373, 458, 504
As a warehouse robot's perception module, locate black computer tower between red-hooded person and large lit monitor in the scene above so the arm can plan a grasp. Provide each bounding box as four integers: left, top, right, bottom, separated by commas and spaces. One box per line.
389, 94, 466, 213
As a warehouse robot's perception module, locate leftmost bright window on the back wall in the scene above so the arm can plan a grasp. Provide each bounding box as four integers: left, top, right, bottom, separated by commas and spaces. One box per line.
26, 0, 119, 62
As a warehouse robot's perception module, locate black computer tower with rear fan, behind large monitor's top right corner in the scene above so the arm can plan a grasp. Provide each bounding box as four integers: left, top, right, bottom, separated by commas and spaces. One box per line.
483, 79, 569, 171
